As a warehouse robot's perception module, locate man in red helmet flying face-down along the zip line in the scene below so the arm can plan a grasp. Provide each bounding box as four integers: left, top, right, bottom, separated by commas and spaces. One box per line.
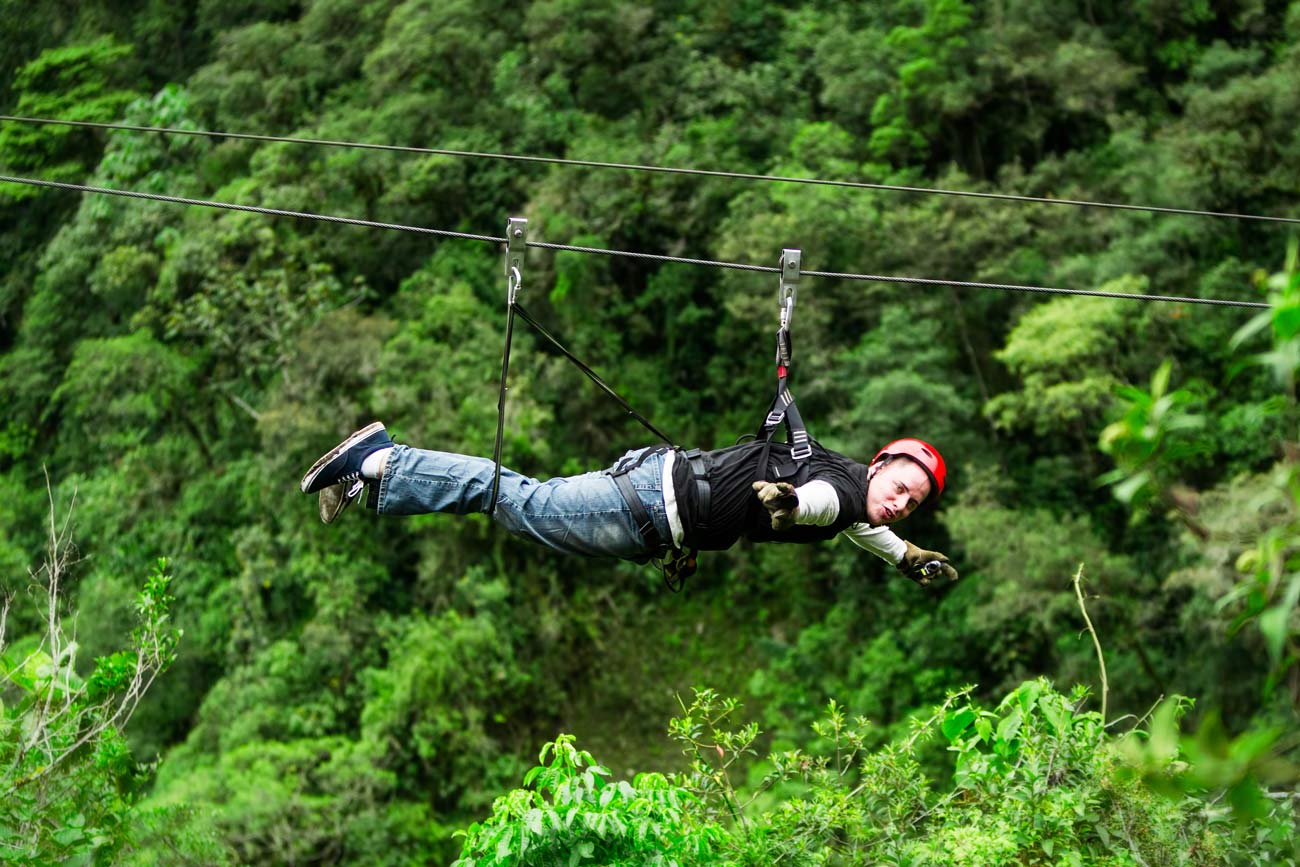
302, 421, 957, 585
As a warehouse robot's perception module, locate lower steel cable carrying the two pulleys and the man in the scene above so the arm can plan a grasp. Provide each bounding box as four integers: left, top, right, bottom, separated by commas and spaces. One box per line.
0, 174, 1269, 309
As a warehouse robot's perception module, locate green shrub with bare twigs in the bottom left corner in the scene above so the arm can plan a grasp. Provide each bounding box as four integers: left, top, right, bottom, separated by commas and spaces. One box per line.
0, 548, 179, 864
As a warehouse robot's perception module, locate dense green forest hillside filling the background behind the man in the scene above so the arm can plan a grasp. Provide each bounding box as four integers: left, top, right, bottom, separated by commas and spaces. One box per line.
0, 0, 1300, 864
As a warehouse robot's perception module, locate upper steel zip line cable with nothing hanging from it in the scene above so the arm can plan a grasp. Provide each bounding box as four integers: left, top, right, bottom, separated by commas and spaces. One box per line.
0, 114, 1300, 224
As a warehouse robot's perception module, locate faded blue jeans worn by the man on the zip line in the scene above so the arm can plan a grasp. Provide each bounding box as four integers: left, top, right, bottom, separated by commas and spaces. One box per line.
377, 446, 670, 560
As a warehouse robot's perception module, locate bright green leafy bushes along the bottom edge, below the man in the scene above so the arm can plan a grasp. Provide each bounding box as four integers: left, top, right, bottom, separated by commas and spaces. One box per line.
456, 679, 1296, 867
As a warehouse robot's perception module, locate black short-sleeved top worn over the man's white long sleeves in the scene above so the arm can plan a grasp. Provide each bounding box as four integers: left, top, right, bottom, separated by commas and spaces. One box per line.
673, 441, 867, 551
